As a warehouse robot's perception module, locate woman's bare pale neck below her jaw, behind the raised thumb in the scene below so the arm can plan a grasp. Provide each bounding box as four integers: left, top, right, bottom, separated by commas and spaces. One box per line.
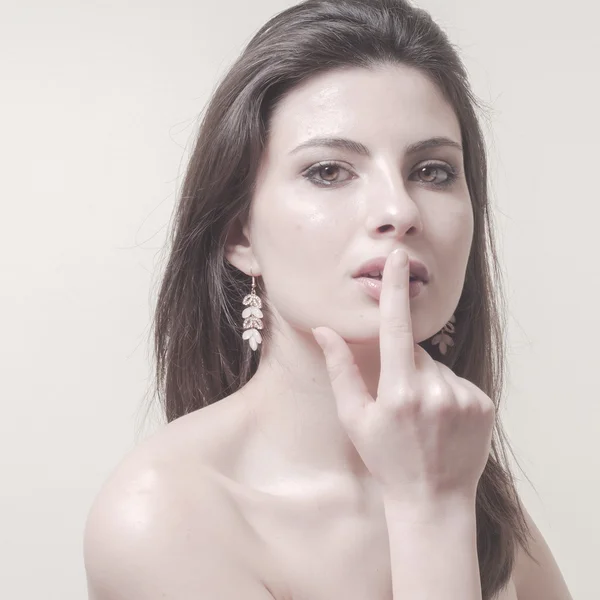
240, 329, 379, 484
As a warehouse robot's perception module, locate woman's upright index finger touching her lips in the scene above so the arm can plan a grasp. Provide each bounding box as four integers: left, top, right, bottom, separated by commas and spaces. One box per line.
379, 249, 416, 384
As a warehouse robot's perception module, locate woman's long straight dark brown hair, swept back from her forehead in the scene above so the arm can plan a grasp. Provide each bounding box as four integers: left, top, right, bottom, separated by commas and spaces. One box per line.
149, 0, 529, 600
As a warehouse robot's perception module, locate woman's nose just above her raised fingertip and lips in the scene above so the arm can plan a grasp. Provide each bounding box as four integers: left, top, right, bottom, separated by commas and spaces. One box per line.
366, 177, 423, 237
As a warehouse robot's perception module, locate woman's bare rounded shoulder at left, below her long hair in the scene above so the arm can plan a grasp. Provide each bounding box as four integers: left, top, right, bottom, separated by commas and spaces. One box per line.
84, 396, 273, 600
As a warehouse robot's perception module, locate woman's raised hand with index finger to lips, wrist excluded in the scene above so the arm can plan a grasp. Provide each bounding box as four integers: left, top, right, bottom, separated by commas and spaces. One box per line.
314, 250, 495, 503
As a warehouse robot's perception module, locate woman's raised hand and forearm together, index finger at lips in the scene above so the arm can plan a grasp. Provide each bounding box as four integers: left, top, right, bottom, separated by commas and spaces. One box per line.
315, 250, 495, 600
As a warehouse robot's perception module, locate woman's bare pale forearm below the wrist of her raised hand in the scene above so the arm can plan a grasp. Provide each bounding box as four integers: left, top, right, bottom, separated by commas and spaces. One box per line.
384, 498, 481, 600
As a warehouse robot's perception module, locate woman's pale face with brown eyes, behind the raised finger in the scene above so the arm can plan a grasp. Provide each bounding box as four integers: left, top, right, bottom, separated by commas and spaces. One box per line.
239, 65, 473, 343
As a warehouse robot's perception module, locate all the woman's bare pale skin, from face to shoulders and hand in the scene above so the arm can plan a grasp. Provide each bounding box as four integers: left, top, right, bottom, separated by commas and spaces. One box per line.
85, 66, 570, 600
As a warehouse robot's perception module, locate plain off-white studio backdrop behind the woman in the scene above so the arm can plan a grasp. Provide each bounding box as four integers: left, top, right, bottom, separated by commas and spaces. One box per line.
0, 0, 600, 600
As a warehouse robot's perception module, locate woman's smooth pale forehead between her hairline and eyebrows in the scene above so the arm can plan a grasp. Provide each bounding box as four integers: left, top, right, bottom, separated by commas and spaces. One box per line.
269, 64, 461, 153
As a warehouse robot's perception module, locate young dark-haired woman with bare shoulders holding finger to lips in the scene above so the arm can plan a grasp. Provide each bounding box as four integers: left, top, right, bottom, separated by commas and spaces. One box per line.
85, 0, 570, 600
